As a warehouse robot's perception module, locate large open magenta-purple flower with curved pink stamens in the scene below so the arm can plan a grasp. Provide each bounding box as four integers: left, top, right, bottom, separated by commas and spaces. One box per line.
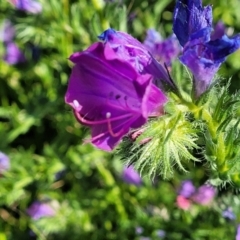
65, 42, 167, 151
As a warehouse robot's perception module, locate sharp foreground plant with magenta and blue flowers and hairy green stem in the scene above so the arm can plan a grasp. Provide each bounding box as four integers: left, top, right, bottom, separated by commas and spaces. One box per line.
65, 0, 240, 187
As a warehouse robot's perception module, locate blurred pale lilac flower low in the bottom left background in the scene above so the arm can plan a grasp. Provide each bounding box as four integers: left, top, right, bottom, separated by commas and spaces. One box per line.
27, 201, 56, 220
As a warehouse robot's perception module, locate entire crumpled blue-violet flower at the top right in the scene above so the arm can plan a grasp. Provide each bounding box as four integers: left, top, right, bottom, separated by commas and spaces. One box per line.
173, 0, 240, 97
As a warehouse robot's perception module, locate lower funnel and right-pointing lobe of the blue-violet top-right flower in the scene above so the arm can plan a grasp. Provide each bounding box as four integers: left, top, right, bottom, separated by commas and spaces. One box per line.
180, 32, 240, 97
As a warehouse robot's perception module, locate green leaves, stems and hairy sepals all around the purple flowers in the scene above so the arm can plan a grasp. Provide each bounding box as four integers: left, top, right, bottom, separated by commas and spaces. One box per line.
0, 0, 240, 240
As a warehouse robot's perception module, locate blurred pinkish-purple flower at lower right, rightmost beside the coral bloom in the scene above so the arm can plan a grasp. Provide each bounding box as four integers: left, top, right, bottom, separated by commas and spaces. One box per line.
192, 185, 216, 205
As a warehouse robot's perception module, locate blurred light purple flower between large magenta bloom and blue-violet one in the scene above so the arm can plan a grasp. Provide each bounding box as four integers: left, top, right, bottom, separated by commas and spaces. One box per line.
143, 29, 181, 66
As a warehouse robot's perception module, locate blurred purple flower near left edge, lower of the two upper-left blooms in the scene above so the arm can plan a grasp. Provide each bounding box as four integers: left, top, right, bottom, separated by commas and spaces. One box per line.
3, 42, 25, 65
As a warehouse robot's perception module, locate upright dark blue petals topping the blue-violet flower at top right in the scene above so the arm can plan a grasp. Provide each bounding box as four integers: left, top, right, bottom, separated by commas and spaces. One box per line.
173, 0, 212, 47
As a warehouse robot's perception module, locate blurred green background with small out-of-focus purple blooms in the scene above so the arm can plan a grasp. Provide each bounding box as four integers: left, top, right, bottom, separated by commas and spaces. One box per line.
0, 0, 240, 240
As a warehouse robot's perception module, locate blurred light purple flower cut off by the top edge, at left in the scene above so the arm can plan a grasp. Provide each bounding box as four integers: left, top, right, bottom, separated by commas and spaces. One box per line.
10, 0, 42, 14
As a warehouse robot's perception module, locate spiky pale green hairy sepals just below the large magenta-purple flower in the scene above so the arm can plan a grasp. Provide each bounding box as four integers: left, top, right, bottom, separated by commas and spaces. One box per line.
118, 108, 199, 179
